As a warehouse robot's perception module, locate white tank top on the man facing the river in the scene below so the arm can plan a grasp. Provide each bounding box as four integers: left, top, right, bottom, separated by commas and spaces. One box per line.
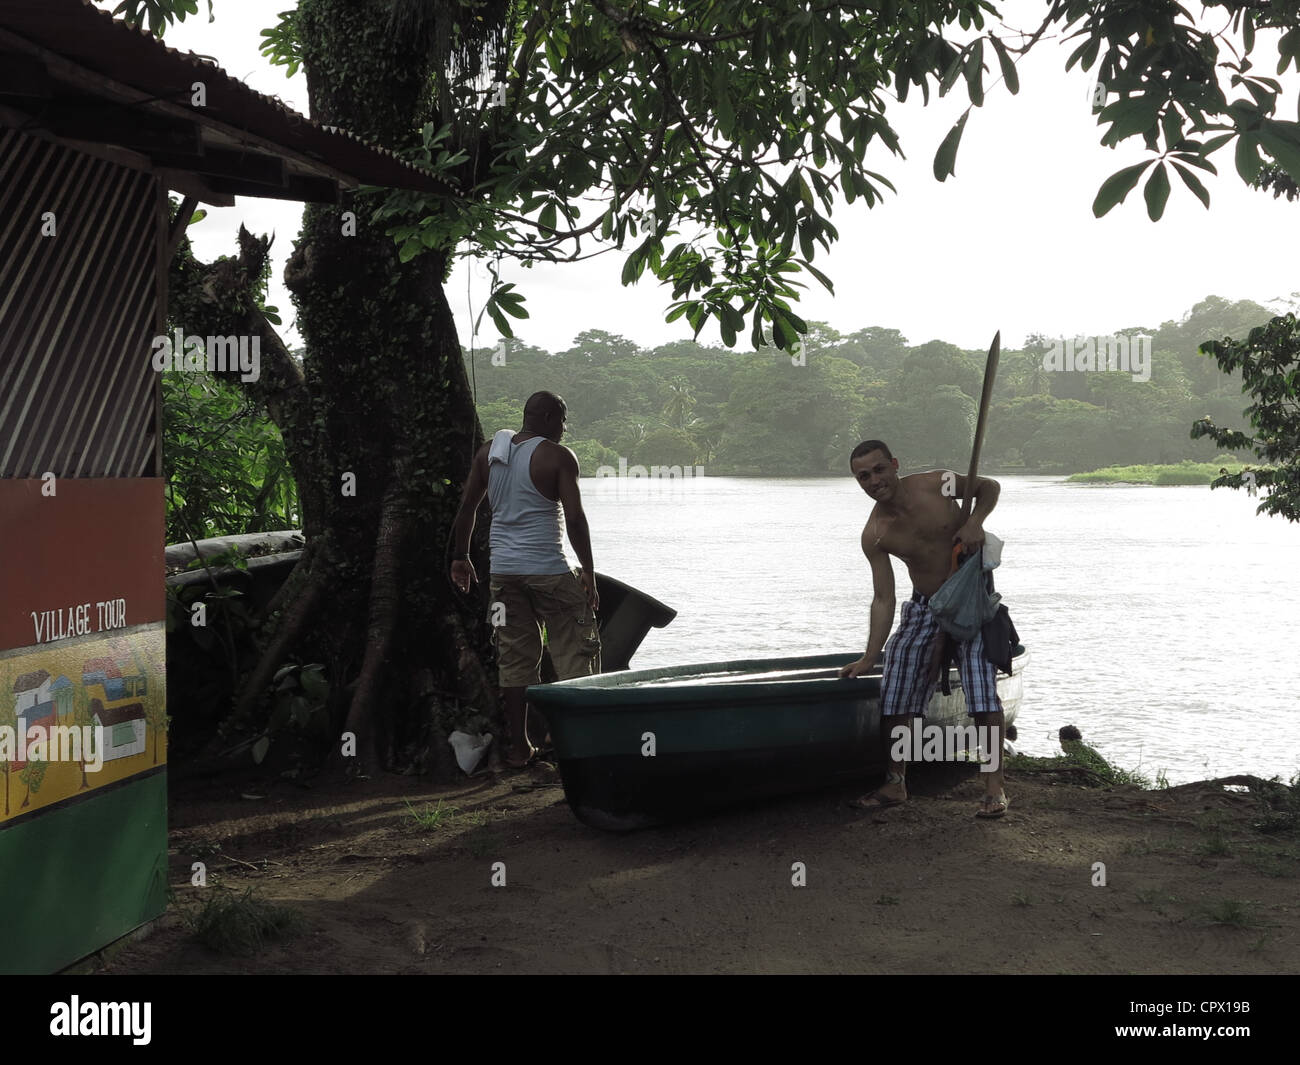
488, 437, 572, 575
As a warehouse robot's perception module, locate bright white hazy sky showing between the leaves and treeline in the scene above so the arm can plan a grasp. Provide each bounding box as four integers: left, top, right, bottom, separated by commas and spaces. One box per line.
149, 0, 1300, 351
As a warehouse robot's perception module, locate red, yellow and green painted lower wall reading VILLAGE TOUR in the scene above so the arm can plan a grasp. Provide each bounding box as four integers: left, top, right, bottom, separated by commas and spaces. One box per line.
0, 477, 166, 973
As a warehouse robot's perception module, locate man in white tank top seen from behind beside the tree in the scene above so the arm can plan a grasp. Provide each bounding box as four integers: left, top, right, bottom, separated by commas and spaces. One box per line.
451, 391, 601, 767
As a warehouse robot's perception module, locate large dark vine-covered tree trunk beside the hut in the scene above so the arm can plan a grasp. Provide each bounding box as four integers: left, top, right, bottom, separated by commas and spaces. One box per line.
173, 0, 501, 776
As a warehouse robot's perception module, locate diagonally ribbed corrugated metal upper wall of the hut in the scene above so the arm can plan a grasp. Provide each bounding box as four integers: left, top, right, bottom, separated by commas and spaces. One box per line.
0, 129, 161, 477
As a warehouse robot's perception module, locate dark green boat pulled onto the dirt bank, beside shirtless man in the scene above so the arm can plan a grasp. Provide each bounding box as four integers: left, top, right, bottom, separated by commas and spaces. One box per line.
528, 646, 1028, 832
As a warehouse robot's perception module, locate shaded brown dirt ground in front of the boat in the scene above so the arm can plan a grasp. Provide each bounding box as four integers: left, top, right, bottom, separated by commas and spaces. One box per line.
104, 766, 1300, 974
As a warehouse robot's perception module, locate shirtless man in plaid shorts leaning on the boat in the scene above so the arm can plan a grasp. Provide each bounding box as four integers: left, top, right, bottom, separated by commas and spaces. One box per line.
840, 440, 1010, 818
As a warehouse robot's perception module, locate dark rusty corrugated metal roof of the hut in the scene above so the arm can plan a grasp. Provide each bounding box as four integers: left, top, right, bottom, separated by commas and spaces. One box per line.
0, 0, 450, 192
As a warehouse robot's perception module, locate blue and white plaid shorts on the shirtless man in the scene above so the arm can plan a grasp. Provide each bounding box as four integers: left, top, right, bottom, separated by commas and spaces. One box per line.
880, 592, 1002, 715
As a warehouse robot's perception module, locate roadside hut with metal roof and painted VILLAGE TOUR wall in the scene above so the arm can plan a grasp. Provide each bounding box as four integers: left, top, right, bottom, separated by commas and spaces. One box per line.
0, 0, 449, 973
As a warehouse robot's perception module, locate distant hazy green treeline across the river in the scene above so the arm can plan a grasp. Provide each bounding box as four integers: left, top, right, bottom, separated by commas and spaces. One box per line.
465, 296, 1273, 476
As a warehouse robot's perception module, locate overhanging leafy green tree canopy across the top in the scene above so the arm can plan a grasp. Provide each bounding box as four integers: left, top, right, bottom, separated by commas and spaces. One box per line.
120, 0, 1300, 348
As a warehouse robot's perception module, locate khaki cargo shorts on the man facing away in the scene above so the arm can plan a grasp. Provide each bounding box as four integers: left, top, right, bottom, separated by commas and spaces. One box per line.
488, 570, 601, 688
